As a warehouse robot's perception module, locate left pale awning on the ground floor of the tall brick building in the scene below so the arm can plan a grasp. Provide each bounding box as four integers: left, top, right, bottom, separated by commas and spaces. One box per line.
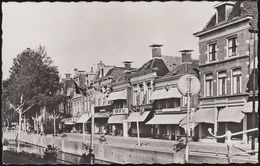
193, 108, 217, 124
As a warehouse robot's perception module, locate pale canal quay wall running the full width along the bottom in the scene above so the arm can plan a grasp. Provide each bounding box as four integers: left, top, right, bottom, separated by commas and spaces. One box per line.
4, 133, 258, 164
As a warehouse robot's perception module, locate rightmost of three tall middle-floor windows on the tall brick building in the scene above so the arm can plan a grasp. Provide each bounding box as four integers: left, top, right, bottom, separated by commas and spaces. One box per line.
232, 69, 242, 94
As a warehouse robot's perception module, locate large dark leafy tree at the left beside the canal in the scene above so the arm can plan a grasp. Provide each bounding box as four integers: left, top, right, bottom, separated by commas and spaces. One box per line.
8, 46, 61, 127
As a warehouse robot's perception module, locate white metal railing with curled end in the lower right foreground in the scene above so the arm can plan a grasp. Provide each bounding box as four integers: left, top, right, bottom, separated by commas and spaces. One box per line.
208, 128, 258, 163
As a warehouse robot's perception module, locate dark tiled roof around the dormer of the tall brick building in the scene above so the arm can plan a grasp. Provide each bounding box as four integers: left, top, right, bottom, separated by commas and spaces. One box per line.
197, 0, 258, 33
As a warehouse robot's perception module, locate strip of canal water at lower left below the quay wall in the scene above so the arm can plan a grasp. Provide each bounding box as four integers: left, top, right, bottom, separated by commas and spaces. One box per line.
3, 140, 111, 164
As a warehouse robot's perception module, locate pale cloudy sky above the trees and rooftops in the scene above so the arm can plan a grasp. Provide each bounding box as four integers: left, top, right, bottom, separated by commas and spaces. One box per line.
2, 1, 219, 79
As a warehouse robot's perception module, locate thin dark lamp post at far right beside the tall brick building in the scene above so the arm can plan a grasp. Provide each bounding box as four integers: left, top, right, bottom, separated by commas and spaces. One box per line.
249, 26, 258, 150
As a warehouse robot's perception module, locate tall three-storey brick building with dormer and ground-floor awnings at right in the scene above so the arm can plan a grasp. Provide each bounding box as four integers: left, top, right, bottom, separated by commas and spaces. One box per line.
194, 1, 257, 141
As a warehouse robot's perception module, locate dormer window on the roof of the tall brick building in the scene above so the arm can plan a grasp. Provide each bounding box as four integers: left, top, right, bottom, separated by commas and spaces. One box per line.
215, 2, 234, 23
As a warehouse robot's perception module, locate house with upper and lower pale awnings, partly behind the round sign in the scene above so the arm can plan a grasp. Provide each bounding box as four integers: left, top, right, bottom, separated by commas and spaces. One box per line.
146, 51, 199, 140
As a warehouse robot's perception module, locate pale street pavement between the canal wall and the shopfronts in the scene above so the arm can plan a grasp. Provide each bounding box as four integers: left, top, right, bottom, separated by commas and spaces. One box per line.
55, 133, 258, 155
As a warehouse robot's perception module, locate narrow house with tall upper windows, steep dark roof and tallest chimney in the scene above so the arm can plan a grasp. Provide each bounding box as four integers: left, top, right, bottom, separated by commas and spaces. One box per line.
126, 45, 181, 137
